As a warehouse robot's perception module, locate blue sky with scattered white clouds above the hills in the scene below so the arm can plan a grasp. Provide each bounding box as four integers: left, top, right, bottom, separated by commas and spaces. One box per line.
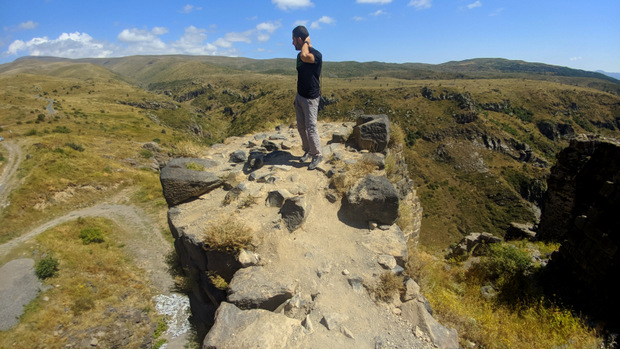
0, 0, 620, 72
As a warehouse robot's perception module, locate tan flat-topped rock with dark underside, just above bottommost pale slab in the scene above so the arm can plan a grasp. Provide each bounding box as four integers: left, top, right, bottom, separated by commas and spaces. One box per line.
228, 266, 297, 311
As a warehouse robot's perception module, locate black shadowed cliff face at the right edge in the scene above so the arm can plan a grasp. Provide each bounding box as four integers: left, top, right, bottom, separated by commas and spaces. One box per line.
537, 137, 620, 323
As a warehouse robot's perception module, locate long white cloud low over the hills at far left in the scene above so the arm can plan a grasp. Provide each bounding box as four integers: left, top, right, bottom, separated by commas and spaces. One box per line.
2, 32, 118, 58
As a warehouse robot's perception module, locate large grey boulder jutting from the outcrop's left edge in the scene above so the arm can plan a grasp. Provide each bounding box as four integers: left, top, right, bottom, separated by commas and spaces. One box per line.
159, 158, 222, 206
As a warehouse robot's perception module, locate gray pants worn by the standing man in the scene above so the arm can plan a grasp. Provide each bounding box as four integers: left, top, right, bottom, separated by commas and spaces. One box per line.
294, 93, 321, 156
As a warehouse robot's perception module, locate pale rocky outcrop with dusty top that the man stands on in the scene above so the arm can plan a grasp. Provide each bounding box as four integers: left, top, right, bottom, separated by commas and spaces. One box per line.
162, 117, 453, 348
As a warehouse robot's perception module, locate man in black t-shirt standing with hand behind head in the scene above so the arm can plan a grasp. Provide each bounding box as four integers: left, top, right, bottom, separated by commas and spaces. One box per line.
293, 25, 323, 170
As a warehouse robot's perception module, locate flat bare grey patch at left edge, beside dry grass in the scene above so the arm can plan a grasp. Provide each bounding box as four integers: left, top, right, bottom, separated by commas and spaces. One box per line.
0, 258, 42, 331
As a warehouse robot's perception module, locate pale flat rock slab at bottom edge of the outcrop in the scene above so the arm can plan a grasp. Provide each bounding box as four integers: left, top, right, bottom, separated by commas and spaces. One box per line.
202, 303, 304, 349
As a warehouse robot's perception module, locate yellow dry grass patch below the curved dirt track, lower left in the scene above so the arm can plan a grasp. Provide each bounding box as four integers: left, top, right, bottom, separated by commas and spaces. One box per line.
0, 218, 157, 348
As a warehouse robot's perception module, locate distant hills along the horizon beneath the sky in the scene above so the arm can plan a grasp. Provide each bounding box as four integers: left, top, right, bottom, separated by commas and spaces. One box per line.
0, 55, 620, 94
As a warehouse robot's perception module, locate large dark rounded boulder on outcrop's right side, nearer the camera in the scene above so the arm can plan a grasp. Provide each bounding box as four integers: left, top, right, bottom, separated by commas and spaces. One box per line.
342, 175, 399, 225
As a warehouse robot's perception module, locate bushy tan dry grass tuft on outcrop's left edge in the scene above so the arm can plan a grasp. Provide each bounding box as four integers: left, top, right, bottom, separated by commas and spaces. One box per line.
204, 217, 253, 253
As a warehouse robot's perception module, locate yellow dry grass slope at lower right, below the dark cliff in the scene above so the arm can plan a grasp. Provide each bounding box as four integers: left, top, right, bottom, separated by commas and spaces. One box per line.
407, 248, 601, 349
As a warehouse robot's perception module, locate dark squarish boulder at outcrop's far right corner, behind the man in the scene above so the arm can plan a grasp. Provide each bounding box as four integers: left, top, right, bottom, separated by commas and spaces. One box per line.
353, 114, 390, 152
